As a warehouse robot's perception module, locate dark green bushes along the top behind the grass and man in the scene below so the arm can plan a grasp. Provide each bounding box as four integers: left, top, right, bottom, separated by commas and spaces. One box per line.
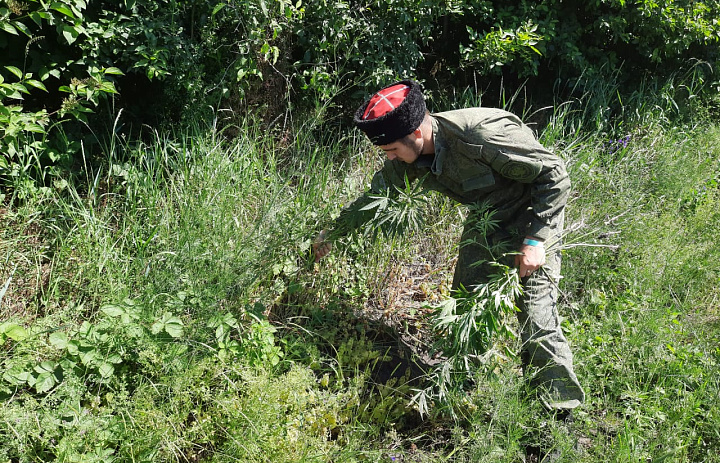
0, 0, 720, 198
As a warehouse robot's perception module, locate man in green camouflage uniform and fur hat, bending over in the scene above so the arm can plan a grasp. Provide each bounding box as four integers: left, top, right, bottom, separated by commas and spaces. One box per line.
314, 81, 584, 412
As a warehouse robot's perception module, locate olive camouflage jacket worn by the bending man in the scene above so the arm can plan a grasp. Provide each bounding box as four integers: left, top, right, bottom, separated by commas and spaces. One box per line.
339, 108, 570, 240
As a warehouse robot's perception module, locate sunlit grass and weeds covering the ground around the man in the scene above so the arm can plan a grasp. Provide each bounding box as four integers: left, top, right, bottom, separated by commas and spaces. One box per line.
0, 70, 720, 462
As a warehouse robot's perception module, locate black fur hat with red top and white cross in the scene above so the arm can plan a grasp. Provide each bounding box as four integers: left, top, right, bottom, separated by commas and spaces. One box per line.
354, 80, 425, 145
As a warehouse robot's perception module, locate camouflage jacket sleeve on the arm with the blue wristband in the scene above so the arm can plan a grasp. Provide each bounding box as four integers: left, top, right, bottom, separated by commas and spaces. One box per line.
482, 116, 570, 240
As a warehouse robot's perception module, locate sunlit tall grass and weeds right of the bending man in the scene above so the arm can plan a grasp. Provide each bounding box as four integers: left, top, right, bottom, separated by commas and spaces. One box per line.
544, 73, 720, 461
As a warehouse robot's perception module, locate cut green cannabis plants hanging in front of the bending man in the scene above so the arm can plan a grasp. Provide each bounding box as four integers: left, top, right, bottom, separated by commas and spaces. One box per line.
348, 176, 522, 414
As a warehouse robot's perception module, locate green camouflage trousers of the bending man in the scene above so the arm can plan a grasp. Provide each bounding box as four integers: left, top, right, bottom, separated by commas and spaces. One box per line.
453, 209, 585, 409
